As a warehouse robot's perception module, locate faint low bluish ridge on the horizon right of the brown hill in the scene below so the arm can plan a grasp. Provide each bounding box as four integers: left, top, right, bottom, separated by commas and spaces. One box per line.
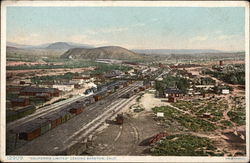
131, 49, 223, 55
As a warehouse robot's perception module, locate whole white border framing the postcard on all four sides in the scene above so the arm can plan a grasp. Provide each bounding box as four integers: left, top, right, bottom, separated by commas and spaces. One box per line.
0, 1, 250, 162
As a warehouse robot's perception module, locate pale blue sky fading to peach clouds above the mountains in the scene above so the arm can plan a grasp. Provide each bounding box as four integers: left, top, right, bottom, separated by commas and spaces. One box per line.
6, 6, 245, 51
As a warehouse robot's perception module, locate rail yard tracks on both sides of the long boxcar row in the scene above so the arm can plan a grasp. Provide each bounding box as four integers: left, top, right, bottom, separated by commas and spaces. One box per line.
8, 82, 148, 154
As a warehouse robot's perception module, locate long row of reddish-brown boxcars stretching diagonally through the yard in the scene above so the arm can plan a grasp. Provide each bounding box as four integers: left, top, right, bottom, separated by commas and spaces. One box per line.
11, 81, 132, 141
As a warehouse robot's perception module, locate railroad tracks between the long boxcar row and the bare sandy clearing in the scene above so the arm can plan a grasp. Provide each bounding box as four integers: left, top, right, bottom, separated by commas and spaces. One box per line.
7, 83, 141, 155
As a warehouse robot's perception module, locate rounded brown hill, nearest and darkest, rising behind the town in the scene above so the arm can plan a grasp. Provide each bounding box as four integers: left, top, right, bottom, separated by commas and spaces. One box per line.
61, 46, 141, 60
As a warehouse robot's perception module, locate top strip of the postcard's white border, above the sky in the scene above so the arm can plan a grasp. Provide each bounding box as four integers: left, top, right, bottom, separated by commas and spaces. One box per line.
0, 1, 248, 7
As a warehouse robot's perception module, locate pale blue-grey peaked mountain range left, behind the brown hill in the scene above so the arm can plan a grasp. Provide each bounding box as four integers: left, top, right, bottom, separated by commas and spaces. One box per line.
7, 42, 93, 50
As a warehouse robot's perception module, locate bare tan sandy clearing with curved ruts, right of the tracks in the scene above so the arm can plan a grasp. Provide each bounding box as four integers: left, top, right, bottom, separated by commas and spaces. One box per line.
86, 90, 188, 156
